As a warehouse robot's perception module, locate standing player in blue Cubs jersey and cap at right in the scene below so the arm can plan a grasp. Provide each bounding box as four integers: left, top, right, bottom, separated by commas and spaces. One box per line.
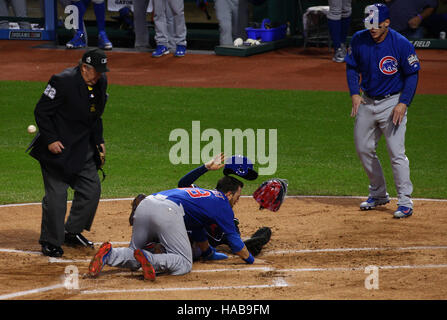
345, 3, 420, 218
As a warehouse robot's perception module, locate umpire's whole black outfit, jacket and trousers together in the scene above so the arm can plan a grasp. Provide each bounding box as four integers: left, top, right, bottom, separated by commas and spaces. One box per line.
30, 49, 108, 256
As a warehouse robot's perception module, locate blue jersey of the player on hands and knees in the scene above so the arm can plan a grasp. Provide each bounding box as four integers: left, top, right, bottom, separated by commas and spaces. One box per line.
154, 188, 245, 252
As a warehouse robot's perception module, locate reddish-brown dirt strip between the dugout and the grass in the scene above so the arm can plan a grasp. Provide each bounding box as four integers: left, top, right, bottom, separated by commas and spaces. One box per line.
0, 40, 447, 94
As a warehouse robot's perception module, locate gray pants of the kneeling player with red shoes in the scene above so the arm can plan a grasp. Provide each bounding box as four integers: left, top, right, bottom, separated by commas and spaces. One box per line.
106, 195, 193, 275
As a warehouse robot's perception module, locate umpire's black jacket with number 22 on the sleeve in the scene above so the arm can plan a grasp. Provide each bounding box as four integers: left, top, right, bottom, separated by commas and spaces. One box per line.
30, 67, 107, 179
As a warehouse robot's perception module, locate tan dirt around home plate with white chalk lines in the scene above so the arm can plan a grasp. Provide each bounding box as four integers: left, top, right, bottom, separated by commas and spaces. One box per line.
0, 197, 447, 300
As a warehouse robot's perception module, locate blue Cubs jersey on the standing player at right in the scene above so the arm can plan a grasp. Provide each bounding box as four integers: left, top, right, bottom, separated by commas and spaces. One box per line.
345, 28, 420, 96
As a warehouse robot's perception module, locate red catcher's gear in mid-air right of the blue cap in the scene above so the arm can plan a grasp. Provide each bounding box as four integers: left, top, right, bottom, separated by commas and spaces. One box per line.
253, 178, 289, 212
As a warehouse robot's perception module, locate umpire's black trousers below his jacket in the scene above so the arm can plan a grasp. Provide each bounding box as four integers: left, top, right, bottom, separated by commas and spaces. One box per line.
39, 148, 101, 246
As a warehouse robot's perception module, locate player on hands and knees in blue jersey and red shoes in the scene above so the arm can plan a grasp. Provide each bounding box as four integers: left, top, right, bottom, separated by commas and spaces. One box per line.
89, 176, 255, 280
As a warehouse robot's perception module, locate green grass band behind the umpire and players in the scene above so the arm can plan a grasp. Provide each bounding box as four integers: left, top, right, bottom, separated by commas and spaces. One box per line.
0, 81, 447, 204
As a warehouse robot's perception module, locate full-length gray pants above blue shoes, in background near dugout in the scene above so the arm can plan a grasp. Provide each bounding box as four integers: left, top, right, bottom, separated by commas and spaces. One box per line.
153, 0, 186, 47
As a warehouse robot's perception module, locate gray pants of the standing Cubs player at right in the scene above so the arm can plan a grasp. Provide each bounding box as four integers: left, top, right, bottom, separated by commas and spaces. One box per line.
354, 94, 413, 208
